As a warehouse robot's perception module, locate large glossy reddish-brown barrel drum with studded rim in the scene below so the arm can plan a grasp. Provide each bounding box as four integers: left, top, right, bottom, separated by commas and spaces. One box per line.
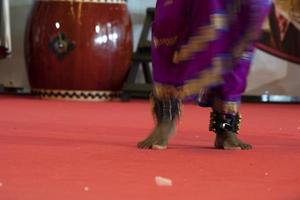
25, 0, 132, 99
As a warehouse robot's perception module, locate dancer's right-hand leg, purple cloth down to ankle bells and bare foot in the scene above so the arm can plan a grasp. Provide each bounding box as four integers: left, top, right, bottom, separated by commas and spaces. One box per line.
200, 0, 270, 150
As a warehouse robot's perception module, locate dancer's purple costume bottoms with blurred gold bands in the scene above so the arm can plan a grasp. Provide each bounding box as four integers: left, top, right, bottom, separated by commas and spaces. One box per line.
152, 0, 271, 102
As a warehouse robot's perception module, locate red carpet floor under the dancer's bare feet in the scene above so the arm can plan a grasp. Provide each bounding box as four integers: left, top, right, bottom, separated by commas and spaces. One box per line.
0, 96, 300, 200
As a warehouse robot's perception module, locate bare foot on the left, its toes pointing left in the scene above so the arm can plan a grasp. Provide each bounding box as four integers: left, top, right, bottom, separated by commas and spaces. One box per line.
137, 120, 176, 150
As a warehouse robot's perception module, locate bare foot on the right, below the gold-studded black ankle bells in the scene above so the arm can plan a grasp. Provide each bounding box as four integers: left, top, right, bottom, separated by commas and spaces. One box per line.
215, 132, 252, 150
